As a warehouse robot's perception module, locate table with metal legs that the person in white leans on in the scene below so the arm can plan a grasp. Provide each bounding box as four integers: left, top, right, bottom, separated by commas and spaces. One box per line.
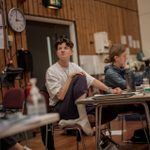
76, 93, 150, 150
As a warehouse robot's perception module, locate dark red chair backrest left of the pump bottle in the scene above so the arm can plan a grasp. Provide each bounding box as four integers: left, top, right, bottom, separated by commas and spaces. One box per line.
2, 88, 25, 109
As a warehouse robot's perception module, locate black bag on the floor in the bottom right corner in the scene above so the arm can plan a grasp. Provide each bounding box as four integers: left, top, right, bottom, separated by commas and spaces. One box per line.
131, 128, 150, 143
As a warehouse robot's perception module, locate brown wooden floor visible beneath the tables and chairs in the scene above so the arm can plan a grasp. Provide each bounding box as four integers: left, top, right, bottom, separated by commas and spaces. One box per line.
22, 120, 148, 150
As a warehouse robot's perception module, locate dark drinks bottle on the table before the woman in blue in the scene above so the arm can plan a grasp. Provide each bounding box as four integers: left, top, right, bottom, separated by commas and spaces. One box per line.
125, 70, 136, 92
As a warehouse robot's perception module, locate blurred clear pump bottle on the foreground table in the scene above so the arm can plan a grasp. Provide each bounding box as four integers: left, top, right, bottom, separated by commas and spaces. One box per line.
27, 78, 46, 115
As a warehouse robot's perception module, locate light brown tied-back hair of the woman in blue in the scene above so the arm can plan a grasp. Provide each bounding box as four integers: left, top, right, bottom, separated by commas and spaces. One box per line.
104, 44, 126, 63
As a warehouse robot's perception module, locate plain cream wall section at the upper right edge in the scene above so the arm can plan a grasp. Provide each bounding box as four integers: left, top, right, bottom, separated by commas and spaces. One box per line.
138, 0, 150, 57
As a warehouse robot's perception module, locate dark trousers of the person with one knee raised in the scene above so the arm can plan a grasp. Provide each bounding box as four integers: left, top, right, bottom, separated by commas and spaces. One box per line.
54, 75, 87, 120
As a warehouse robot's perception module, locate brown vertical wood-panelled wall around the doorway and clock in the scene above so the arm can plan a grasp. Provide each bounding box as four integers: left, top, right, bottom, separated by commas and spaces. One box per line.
0, 0, 140, 99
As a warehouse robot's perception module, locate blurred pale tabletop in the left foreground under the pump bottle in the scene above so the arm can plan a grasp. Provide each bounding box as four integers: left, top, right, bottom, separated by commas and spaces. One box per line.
0, 113, 59, 138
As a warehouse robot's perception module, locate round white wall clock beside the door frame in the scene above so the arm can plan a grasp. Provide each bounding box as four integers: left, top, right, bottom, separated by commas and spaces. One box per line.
8, 8, 26, 32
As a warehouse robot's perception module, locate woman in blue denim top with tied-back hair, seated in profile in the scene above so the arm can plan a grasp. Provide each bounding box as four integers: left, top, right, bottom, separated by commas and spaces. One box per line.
104, 44, 148, 90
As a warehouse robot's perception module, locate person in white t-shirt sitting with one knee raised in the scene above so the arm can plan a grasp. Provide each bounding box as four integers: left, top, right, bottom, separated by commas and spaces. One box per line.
45, 38, 121, 135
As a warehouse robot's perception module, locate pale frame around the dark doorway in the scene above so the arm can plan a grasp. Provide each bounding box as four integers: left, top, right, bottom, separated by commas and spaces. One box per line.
25, 15, 79, 64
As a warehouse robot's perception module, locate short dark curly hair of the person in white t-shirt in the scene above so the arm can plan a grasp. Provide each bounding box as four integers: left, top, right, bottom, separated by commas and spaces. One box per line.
55, 37, 74, 50
